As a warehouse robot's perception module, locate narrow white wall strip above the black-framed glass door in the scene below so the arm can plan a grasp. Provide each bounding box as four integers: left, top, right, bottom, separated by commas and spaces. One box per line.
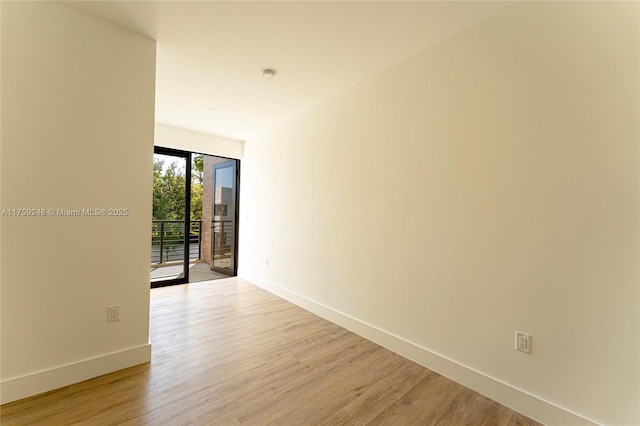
155, 124, 244, 159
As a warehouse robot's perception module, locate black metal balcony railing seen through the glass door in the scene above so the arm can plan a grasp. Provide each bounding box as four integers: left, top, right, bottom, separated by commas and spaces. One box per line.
151, 220, 202, 265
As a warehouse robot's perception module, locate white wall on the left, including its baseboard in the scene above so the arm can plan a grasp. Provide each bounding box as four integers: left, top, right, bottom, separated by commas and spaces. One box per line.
1, 2, 155, 403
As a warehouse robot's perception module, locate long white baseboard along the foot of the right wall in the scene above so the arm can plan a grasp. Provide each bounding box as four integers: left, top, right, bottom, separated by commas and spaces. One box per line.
238, 271, 598, 426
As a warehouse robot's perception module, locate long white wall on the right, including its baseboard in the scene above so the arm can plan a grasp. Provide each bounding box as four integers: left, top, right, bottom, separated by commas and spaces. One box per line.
239, 2, 640, 425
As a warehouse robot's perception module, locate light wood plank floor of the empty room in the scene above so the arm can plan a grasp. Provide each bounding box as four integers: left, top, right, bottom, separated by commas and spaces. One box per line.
1, 278, 538, 426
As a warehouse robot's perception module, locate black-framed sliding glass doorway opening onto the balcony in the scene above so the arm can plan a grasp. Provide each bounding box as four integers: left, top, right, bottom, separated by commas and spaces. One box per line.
151, 147, 239, 288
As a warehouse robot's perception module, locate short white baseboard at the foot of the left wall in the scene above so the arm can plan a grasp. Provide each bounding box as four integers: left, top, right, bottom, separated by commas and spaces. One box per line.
0, 343, 151, 404
